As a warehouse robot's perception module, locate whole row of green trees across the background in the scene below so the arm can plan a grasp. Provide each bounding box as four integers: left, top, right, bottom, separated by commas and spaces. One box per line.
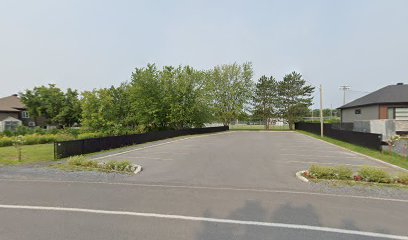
20, 63, 314, 132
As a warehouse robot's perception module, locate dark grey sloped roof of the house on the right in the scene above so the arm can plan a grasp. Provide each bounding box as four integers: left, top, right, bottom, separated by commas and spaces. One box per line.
339, 84, 408, 109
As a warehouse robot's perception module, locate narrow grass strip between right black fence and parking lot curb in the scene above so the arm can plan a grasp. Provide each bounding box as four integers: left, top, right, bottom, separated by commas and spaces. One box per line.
297, 131, 408, 172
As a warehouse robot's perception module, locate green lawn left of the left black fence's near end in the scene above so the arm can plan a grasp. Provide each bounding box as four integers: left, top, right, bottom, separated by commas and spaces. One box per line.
0, 144, 54, 166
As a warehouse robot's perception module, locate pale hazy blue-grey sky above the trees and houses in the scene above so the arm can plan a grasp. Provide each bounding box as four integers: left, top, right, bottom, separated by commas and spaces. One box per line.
0, 0, 408, 108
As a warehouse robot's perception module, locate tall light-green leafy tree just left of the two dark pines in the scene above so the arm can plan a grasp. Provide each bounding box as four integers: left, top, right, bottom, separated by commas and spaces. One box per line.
208, 63, 253, 126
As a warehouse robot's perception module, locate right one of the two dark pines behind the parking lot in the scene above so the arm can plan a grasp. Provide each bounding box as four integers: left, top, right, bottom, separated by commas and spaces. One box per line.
278, 72, 315, 129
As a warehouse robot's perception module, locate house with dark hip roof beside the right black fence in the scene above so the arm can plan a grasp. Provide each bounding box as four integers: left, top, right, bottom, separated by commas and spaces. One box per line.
338, 83, 408, 139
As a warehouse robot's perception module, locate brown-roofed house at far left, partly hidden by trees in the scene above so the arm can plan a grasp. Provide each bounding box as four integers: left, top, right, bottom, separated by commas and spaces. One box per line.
0, 94, 35, 132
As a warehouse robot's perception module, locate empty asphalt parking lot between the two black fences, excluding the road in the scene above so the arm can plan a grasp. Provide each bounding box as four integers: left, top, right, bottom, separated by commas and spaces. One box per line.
91, 131, 398, 189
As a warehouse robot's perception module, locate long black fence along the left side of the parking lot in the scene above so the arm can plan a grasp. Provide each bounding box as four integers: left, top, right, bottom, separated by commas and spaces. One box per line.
54, 127, 229, 159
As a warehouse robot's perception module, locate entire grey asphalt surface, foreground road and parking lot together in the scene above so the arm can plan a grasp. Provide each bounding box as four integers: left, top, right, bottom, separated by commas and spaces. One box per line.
0, 132, 408, 239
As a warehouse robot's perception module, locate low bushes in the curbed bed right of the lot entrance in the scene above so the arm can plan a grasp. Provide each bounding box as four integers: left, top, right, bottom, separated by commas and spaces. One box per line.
305, 165, 408, 185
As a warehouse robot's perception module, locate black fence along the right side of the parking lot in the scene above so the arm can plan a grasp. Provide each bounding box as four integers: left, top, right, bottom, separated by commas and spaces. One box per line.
295, 122, 382, 150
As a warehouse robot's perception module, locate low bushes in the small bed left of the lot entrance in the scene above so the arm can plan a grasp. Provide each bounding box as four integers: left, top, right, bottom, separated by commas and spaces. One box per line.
68, 155, 135, 173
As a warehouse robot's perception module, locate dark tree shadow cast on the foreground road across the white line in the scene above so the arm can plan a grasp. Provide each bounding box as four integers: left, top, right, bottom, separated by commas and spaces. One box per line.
194, 201, 384, 240
